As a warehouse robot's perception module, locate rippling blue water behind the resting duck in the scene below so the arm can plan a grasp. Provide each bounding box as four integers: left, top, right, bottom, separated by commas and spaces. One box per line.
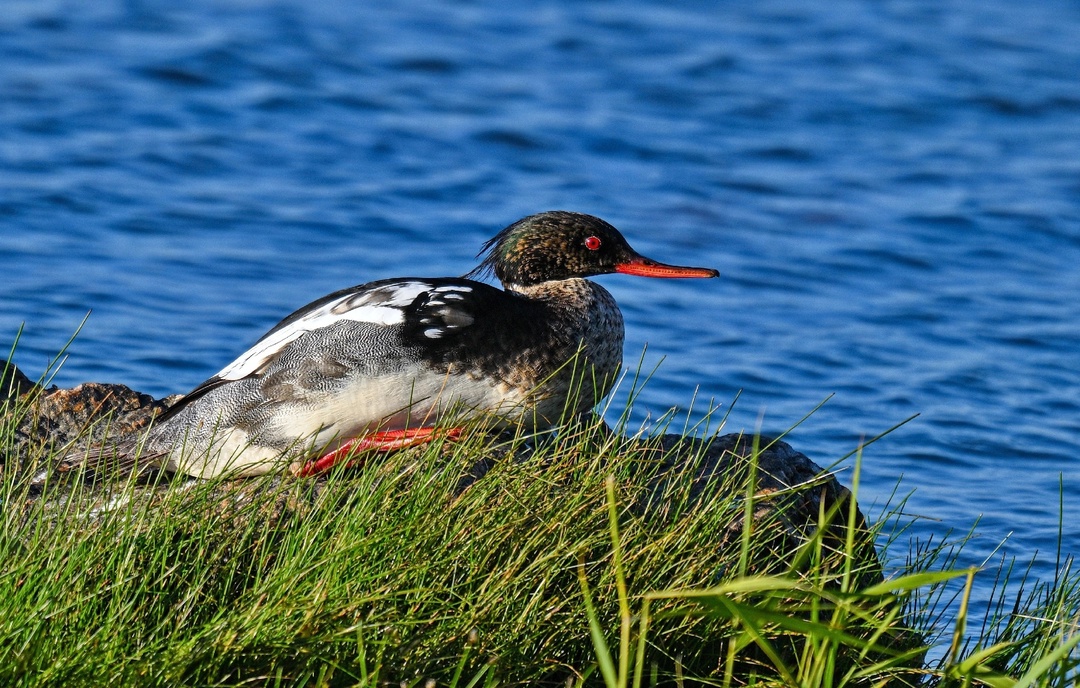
0, 0, 1080, 613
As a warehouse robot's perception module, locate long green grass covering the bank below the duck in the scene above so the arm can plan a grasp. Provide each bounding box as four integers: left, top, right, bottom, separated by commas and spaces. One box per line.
0, 362, 1080, 687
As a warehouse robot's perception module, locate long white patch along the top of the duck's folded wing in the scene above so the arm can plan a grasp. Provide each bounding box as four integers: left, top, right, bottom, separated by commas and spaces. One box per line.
214, 280, 438, 380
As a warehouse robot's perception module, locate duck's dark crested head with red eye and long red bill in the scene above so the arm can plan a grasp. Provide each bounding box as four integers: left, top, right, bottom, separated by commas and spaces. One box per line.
469, 211, 719, 286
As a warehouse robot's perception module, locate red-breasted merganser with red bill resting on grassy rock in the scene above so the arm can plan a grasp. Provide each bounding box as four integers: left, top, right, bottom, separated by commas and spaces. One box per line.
82, 212, 719, 477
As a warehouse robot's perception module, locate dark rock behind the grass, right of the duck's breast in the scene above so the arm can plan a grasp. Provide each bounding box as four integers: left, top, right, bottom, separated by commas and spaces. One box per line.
458, 417, 882, 584
